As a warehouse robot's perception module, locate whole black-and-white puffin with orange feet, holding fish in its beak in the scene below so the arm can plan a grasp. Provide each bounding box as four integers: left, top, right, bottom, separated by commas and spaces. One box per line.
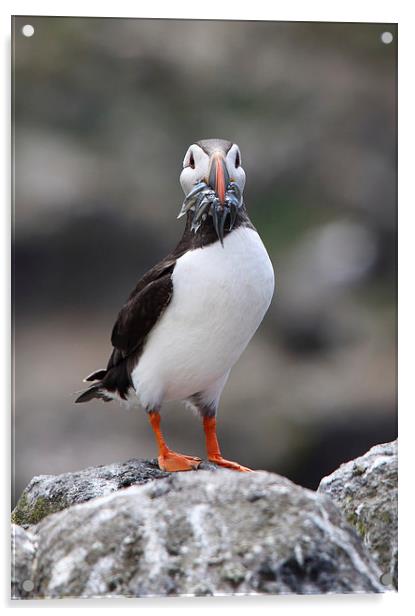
75, 139, 274, 472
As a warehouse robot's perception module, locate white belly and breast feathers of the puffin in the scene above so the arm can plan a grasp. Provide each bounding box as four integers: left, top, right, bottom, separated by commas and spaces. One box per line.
132, 227, 274, 406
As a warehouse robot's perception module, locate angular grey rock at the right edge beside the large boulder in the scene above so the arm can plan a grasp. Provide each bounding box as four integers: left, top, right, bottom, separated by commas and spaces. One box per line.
318, 441, 398, 588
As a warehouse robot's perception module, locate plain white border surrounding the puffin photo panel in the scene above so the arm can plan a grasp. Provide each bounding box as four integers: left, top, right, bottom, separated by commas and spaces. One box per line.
0, 0, 415, 616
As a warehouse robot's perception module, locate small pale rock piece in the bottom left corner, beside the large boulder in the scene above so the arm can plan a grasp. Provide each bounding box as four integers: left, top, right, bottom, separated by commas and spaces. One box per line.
11, 524, 37, 599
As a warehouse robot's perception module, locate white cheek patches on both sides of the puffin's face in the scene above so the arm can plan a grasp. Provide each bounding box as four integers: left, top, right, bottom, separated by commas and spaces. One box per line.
180, 143, 245, 195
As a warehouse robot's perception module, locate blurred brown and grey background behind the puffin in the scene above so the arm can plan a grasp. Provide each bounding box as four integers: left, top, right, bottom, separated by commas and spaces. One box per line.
13, 17, 397, 506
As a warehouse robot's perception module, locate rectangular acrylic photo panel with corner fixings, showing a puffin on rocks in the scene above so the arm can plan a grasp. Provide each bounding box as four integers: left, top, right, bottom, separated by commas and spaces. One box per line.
12, 16, 398, 599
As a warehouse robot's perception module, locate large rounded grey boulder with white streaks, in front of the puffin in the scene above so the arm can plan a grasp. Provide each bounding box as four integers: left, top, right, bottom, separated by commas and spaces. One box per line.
13, 470, 384, 597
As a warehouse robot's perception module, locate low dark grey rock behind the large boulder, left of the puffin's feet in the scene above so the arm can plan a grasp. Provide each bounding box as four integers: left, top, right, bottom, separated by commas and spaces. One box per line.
12, 460, 221, 528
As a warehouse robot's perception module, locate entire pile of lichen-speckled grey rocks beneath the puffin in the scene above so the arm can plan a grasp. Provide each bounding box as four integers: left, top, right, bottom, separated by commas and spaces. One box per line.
12, 443, 397, 598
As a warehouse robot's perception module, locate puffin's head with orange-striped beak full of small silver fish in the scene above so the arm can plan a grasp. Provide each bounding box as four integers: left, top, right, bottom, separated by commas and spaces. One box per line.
178, 139, 245, 244
